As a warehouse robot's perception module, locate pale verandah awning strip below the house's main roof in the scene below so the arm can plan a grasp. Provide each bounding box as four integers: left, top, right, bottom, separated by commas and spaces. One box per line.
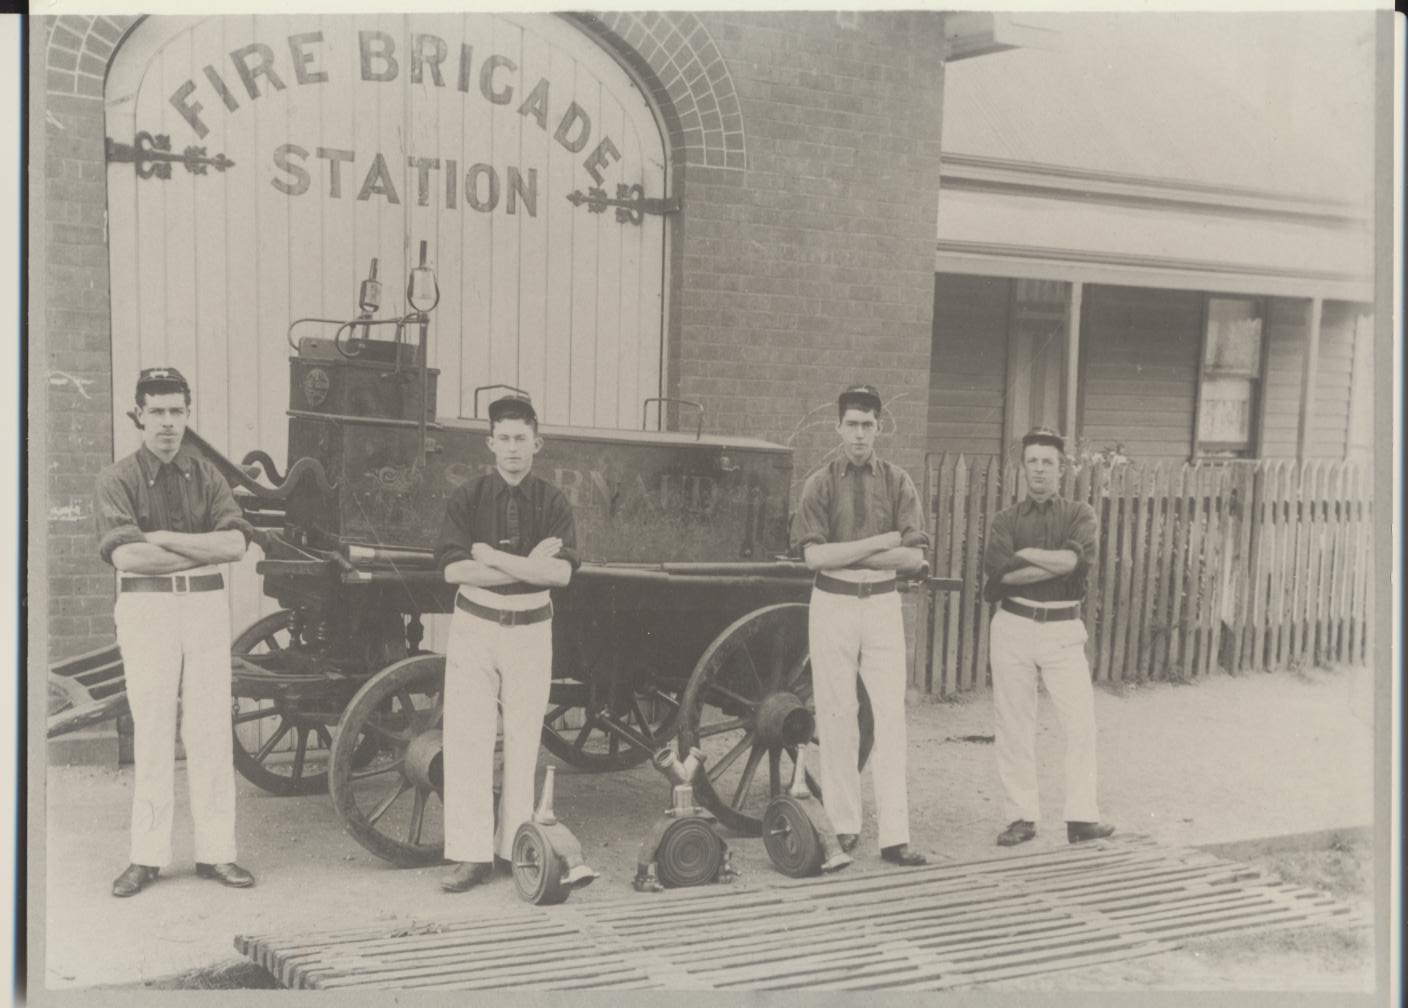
935, 158, 1373, 300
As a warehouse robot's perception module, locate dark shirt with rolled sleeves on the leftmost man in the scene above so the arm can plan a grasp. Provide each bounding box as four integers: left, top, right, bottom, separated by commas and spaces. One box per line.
97, 441, 252, 563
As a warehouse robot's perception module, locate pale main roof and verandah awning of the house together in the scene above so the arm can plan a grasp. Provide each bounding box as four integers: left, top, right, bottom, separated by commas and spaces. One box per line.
938, 13, 1374, 300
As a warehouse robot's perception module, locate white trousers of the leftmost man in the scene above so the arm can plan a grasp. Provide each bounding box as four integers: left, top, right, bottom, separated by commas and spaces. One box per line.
113, 582, 235, 867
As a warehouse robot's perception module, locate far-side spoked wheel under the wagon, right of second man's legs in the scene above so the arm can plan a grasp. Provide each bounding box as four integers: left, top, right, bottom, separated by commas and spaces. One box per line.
542, 676, 680, 771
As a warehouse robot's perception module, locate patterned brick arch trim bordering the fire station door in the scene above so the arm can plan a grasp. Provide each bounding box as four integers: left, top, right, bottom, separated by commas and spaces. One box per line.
45, 11, 746, 169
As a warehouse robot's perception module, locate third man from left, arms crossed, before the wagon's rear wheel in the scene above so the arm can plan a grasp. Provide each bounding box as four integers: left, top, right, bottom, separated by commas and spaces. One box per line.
794, 384, 929, 864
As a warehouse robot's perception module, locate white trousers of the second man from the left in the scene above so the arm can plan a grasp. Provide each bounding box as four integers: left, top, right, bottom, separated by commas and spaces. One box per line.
444, 608, 552, 862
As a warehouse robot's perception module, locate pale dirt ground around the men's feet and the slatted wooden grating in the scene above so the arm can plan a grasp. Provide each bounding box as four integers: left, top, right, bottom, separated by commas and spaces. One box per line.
41, 669, 1374, 991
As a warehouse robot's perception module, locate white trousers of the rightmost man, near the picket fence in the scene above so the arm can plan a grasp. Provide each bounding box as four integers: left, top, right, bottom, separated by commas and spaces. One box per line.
990, 608, 1100, 822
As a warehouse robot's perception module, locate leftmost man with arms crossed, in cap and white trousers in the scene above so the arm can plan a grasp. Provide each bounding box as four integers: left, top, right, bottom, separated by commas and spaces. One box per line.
97, 367, 255, 897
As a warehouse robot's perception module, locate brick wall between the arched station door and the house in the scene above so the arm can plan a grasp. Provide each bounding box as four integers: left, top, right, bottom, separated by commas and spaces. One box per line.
672, 11, 943, 492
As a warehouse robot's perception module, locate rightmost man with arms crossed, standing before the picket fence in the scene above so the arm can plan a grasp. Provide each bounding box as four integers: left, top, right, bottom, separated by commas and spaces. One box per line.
983, 427, 1115, 848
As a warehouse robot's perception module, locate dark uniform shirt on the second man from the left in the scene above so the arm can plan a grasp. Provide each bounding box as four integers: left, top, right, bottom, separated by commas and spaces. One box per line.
435, 469, 579, 596
